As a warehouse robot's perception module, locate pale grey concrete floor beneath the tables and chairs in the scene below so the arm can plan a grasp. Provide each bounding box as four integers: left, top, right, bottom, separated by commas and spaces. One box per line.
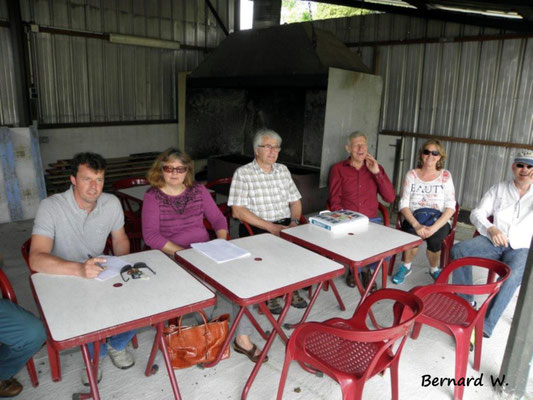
0, 221, 533, 400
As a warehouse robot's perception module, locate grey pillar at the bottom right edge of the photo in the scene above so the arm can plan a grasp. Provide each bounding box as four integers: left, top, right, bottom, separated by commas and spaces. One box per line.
499, 240, 533, 399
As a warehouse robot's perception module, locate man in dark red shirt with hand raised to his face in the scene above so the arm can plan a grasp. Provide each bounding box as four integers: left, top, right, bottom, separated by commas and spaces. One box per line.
329, 132, 396, 287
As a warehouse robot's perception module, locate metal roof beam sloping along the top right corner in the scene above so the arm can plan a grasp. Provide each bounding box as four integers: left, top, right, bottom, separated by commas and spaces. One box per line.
300, 0, 533, 33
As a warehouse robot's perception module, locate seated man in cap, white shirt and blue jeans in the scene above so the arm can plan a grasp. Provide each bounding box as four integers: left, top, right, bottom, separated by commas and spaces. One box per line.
451, 150, 533, 337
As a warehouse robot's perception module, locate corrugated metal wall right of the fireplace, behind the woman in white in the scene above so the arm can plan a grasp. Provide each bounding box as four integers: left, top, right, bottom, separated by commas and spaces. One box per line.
313, 14, 533, 209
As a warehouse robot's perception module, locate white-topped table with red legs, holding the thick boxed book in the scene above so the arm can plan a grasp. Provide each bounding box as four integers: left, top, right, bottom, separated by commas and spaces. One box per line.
281, 222, 422, 307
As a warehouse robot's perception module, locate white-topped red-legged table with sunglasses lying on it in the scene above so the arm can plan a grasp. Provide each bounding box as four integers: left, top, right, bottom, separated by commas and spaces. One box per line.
31, 250, 216, 399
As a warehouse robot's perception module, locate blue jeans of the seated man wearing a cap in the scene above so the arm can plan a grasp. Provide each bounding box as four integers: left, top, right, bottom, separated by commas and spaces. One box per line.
451, 235, 529, 336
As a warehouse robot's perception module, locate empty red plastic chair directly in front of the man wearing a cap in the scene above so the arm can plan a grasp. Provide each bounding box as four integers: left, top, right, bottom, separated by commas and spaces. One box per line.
411, 257, 511, 400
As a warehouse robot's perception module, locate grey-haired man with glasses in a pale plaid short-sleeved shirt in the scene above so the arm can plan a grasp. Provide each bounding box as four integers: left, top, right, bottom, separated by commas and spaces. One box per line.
228, 129, 307, 314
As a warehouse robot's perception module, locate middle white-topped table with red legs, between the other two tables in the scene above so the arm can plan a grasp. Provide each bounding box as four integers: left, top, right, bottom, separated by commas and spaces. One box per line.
175, 233, 344, 399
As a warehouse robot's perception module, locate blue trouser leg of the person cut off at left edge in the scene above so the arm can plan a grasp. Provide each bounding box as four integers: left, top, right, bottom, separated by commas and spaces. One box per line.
0, 298, 46, 380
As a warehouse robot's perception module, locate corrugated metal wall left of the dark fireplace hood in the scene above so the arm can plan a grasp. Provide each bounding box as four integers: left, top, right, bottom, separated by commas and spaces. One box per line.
0, 0, 234, 125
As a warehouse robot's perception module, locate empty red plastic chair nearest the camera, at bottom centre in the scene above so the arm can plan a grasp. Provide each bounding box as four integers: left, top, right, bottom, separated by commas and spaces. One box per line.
277, 289, 423, 400
